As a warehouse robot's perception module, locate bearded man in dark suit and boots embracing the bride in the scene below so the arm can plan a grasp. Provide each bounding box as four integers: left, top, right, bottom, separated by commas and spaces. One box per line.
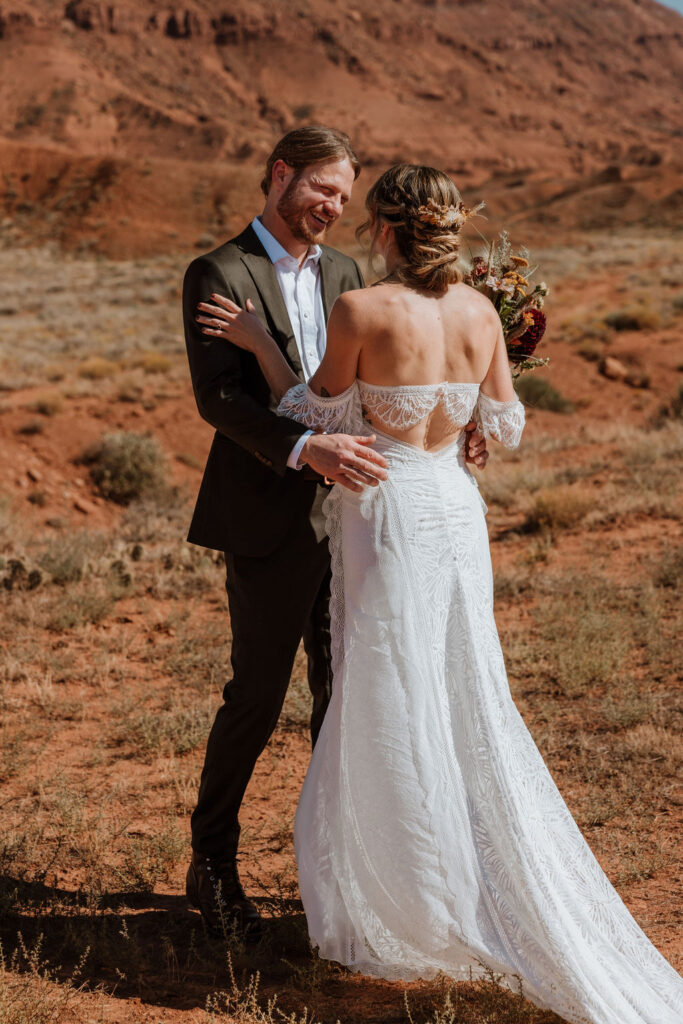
182, 126, 486, 938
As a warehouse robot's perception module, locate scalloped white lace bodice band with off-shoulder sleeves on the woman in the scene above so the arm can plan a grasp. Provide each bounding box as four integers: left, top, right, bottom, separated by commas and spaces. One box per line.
278, 379, 524, 447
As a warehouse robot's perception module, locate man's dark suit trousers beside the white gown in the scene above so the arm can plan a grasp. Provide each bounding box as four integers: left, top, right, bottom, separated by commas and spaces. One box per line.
191, 509, 332, 857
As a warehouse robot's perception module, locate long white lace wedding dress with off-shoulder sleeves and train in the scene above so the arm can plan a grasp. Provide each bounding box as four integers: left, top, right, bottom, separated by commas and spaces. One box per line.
279, 381, 683, 1024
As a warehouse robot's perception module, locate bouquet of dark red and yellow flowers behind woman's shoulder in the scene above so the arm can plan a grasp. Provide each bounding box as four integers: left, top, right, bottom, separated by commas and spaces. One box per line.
465, 231, 550, 378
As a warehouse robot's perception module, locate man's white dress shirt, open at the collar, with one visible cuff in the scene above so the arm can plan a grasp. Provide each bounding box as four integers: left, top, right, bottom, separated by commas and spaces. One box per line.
251, 217, 328, 469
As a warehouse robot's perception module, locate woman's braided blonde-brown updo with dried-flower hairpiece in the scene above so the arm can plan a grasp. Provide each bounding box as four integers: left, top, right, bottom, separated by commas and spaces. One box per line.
356, 164, 478, 293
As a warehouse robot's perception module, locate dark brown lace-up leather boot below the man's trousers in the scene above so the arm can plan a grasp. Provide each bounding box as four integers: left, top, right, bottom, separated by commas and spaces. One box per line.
185, 852, 263, 942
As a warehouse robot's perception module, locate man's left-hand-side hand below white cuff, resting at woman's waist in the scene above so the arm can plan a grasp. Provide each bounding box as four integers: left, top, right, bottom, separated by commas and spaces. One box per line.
299, 434, 388, 490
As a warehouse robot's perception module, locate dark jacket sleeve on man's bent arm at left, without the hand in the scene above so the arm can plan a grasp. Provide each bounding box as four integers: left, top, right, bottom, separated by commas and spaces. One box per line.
182, 257, 306, 476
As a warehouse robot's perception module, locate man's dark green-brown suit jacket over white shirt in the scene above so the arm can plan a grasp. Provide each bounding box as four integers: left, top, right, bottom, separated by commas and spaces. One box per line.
182, 226, 364, 556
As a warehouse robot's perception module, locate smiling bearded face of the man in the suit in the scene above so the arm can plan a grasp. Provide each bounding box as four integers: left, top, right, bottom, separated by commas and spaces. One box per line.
278, 159, 354, 245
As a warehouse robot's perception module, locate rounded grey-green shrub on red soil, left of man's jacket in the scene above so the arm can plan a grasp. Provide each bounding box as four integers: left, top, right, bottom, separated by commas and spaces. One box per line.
80, 431, 168, 505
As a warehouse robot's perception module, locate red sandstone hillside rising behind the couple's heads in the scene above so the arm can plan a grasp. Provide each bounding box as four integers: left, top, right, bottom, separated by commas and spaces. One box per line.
0, 0, 683, 255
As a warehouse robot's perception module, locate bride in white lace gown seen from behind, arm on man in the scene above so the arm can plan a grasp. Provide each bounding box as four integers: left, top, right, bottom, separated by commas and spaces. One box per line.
200, 165, 683, 1024
